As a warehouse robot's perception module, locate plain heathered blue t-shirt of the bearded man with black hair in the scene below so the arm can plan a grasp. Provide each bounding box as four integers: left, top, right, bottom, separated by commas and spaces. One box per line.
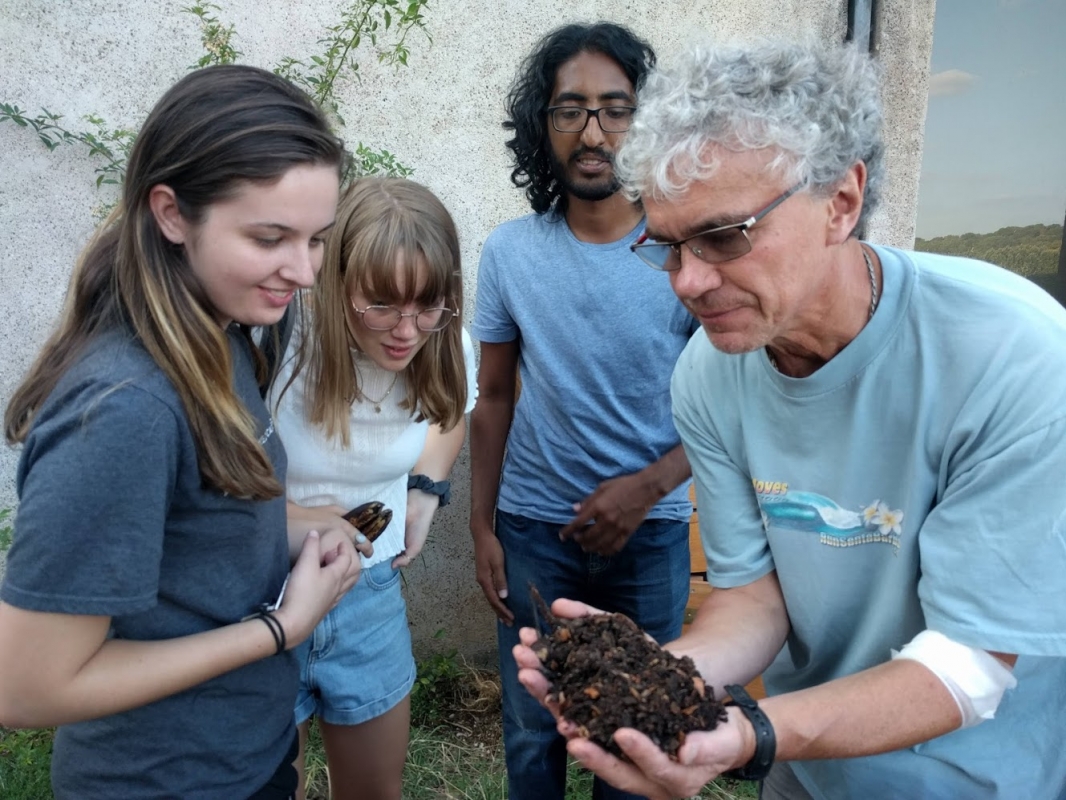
471, 213, 698, 523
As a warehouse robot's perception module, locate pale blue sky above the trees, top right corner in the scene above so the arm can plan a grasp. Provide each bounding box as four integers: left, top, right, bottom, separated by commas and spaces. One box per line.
918, 0, 1066, 239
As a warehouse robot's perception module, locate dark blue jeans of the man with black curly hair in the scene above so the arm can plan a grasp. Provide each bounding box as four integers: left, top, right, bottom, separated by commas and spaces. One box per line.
496, 511, 690, 800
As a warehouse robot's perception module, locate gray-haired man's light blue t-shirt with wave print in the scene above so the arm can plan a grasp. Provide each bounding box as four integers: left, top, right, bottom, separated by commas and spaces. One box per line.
673, 247, 1066, 800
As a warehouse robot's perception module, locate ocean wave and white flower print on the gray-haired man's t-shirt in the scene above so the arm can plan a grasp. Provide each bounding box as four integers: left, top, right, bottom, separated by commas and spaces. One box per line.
752, 480, 903, 549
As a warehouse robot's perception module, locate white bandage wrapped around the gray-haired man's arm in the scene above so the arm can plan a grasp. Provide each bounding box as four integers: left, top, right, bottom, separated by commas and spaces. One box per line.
892, 630, 1018, 727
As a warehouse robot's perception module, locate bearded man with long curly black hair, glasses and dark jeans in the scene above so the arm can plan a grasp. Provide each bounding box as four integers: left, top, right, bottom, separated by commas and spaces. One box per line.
470, 22, 697, 800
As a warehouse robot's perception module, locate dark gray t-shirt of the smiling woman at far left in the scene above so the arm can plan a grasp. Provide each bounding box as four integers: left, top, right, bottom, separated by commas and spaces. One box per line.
0, 330, 298, 800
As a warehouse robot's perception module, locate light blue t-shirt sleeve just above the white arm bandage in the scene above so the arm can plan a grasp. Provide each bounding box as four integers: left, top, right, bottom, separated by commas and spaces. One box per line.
918, 413, 1066, 656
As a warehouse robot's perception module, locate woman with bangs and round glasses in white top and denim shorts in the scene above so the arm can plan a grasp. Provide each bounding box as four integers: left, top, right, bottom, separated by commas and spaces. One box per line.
271, 177, 475, 800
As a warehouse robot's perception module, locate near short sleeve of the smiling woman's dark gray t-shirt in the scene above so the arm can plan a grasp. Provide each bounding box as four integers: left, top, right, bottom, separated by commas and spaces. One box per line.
0, 382, 181, 615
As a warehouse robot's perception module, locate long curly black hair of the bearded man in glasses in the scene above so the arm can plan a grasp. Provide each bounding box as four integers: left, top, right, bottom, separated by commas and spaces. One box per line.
503, 22, 656, 214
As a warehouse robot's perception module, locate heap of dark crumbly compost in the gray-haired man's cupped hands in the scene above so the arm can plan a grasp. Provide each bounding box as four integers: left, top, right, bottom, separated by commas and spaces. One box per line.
530, 585, 726, 758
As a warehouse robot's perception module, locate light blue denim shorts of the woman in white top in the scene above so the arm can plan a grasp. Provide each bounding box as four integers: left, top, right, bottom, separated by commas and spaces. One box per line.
296, 561, 415, 725
